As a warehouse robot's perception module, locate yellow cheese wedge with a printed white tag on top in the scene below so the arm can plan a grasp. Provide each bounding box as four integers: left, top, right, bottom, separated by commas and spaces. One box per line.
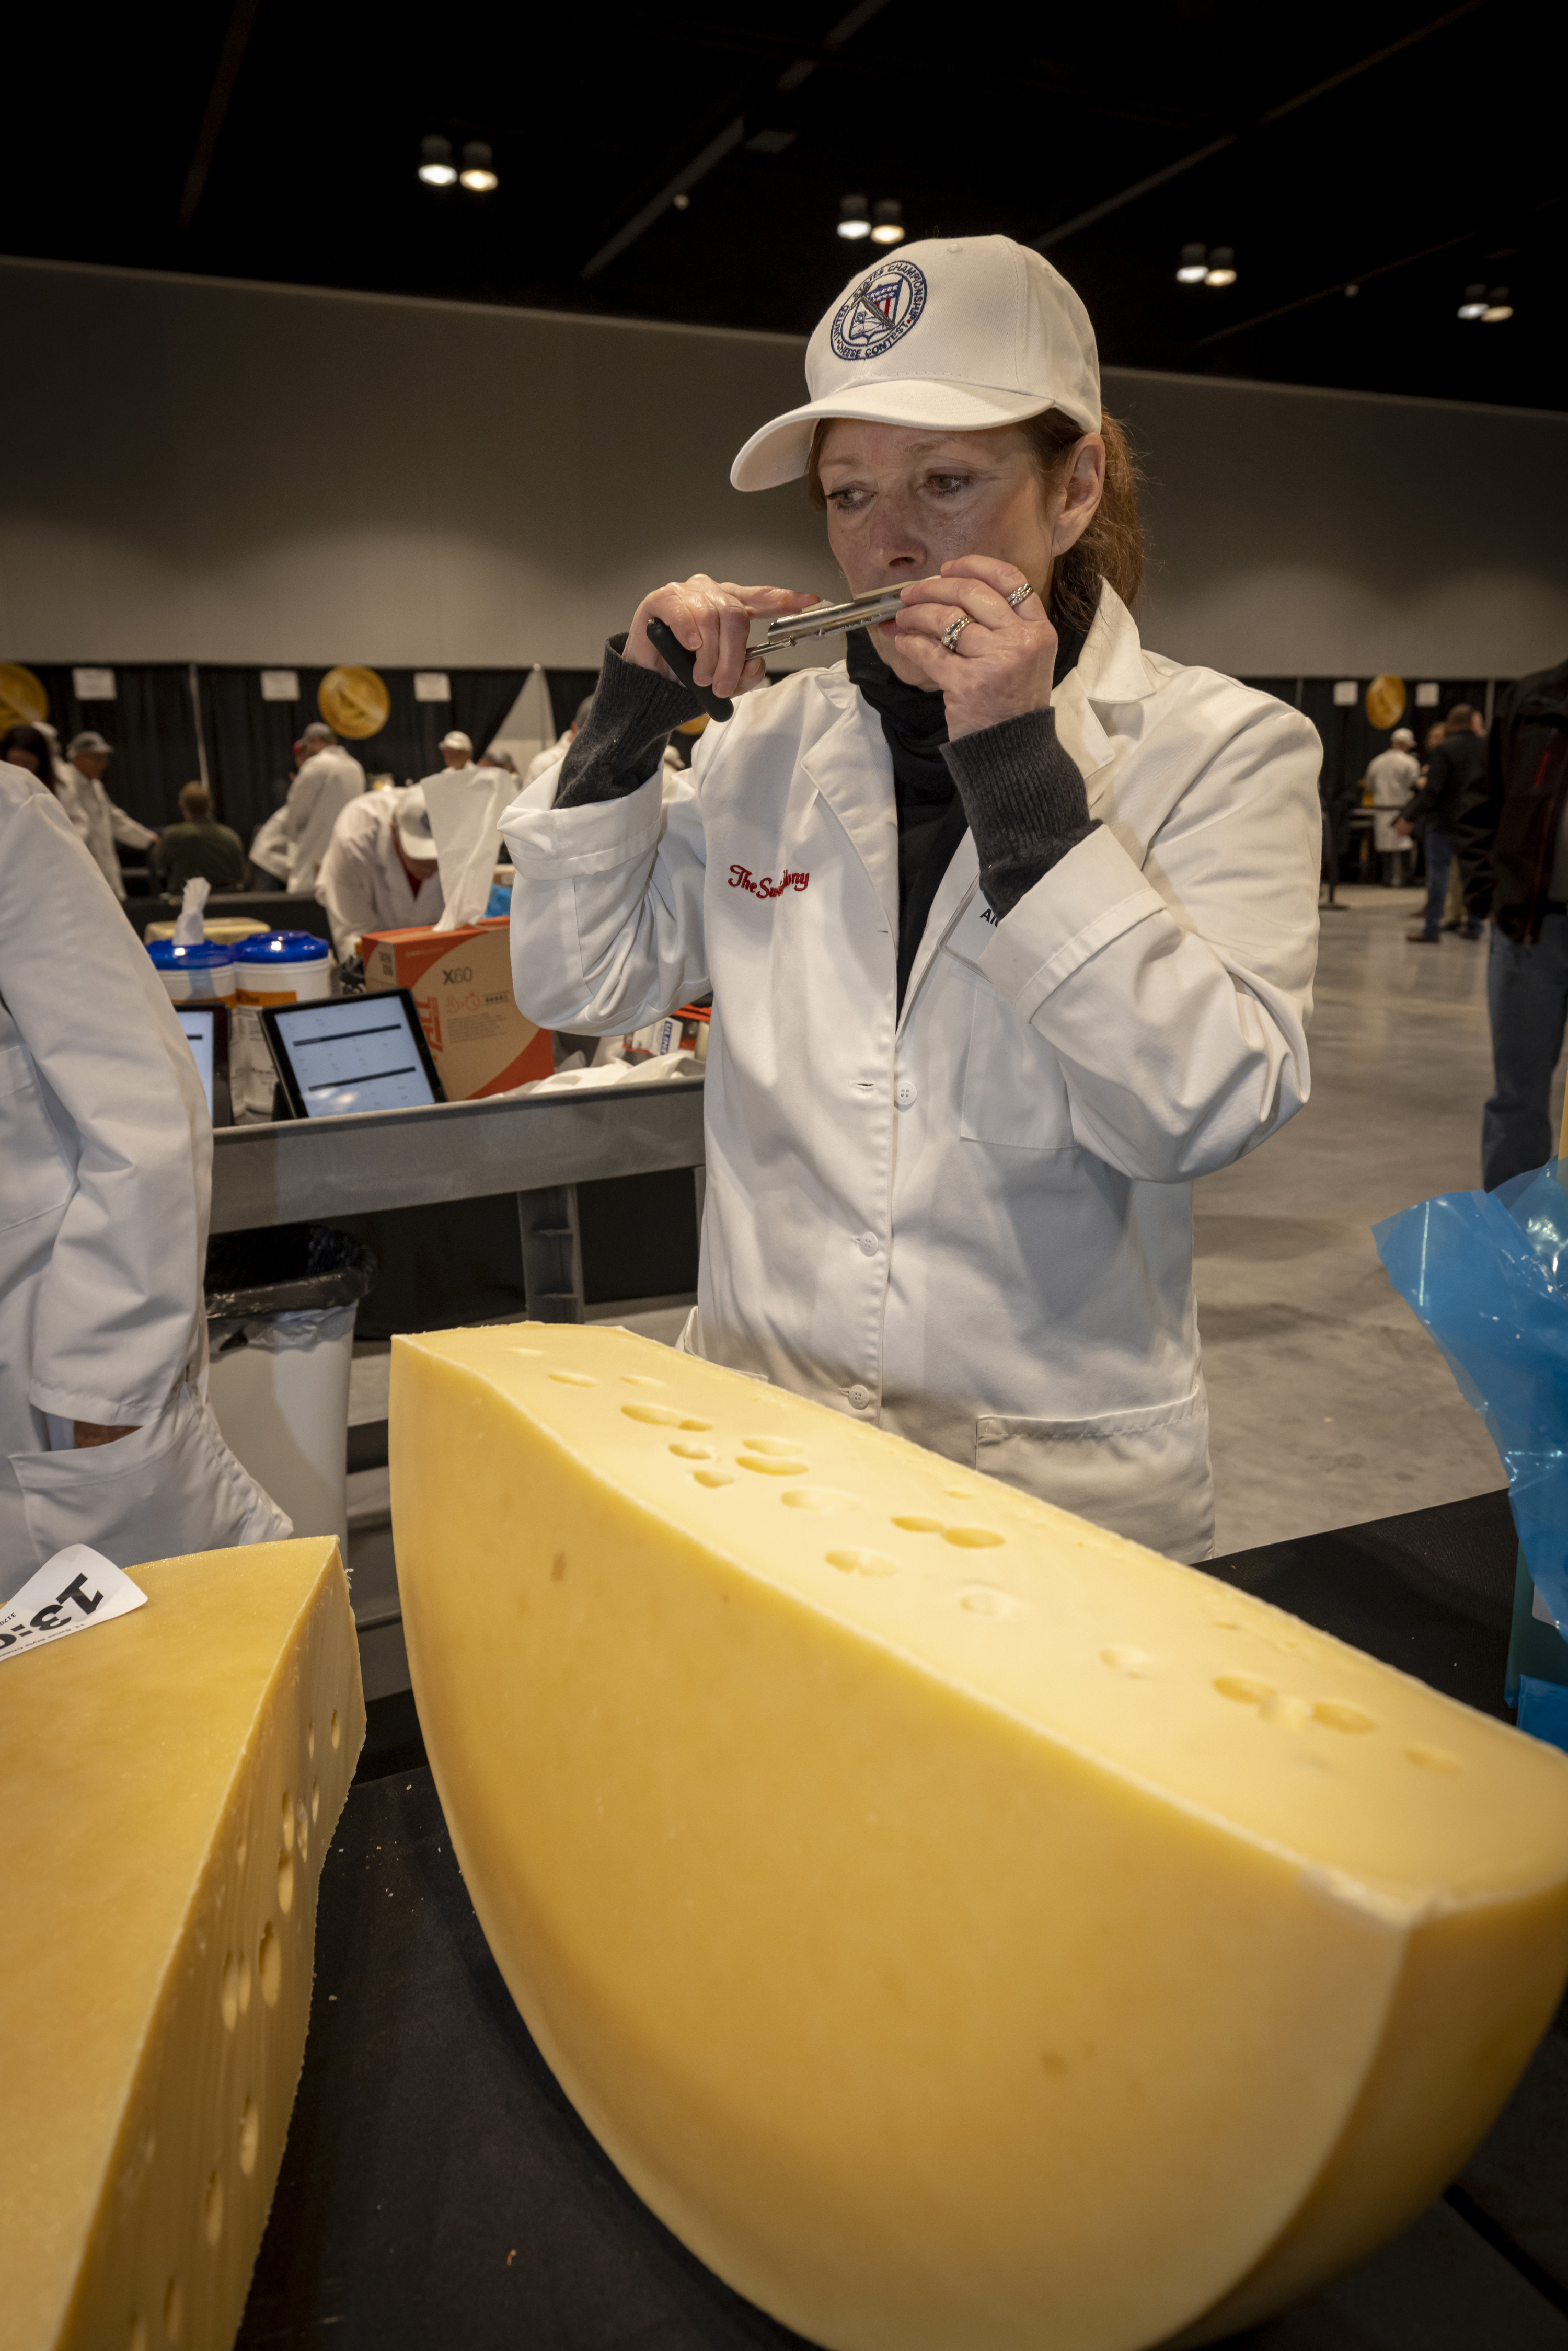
0, 1538, 364, 2351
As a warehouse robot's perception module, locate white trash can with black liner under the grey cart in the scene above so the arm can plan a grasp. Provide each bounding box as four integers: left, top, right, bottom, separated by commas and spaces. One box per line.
207, 1225, 376, 1561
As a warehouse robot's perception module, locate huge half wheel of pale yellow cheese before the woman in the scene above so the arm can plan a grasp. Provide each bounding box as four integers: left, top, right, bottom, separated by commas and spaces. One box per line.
390, 1323, 1568, 2351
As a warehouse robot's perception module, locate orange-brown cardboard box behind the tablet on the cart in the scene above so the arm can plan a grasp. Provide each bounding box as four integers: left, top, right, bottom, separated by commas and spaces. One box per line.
360, 917, 555, 1103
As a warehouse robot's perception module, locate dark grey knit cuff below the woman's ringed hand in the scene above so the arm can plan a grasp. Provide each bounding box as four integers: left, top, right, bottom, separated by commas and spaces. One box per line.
943, 710, 1096, 917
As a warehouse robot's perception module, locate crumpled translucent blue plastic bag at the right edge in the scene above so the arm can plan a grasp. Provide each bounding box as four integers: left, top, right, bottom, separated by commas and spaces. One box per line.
1373, 1159, 1568, 1627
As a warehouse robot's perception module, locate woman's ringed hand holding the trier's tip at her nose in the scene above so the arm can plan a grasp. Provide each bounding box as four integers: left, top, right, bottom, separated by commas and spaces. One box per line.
898, 555, 1055, 743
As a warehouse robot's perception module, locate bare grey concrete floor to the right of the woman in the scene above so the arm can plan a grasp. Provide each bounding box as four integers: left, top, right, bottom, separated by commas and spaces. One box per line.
1194, 889, 1561, 1557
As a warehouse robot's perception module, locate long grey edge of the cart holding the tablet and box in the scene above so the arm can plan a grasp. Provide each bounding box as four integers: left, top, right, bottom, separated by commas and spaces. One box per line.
212, 1077, 703, 1232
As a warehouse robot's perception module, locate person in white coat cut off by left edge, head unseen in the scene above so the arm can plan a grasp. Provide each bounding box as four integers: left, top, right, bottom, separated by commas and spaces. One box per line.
0, 766, 289, 1601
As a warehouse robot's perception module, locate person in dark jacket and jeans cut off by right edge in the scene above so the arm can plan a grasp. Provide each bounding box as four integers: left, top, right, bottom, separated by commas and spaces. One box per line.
1458, 661, 1568, 1192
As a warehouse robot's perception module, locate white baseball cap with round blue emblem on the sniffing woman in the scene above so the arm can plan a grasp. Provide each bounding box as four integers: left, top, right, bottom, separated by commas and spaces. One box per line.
729, 237, 1100, 489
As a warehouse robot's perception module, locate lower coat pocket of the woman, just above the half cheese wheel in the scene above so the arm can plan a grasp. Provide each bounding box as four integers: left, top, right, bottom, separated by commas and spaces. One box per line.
976, 1382, 1213, 1563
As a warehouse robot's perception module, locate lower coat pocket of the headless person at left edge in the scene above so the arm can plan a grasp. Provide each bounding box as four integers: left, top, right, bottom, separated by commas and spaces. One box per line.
11, 1387, 294, 1573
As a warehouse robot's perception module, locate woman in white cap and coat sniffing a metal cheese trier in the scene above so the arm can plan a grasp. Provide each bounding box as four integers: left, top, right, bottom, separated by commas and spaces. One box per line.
505, 237, 1319, 1559
